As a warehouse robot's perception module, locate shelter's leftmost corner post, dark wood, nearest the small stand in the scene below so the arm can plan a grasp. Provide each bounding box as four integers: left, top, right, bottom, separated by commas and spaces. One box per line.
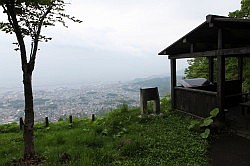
170, 59, 176, 109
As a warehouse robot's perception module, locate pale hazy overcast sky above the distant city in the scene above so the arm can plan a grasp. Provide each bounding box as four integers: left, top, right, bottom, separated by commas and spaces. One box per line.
0, 0, 240, 87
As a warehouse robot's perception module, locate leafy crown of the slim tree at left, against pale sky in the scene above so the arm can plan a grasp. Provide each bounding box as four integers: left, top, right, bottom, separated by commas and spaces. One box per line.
0, 0, 81, 42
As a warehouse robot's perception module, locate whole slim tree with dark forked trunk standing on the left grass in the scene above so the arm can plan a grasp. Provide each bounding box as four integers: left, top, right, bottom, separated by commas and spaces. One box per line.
0, 0, 81, 158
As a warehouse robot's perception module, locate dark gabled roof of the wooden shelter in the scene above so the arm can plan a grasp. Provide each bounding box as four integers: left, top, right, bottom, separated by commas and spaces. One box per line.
159, 15, 250, 59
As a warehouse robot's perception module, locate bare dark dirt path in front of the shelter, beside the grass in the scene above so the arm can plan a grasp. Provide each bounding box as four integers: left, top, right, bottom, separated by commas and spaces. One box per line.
208, 134, 250, 166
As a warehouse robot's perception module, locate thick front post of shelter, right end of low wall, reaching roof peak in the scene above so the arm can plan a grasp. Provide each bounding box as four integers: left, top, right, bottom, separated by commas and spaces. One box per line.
217, 29, 225, 120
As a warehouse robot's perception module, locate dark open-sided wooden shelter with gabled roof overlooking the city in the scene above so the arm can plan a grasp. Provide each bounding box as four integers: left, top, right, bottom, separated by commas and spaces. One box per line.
159, 15, 250, 117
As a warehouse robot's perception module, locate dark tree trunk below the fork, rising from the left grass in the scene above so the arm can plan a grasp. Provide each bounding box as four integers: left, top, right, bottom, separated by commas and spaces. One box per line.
23, 72, 35, 158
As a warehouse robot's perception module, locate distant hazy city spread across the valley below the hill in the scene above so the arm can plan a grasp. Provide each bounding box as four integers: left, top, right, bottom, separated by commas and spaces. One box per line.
0, 77, 176, 123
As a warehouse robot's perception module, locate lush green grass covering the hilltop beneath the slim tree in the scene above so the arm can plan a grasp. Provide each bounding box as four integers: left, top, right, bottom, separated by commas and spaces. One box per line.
0, 100, 208, 166
